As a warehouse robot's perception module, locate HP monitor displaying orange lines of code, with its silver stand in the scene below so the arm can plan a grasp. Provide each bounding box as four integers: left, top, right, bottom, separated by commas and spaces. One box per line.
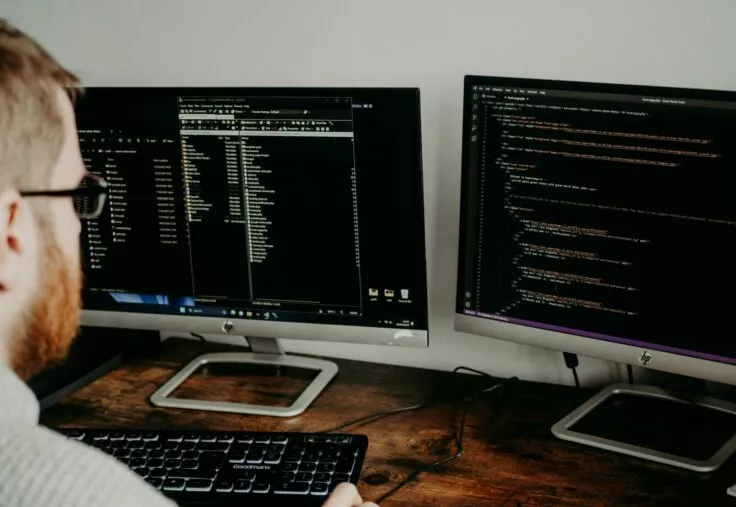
455, 76, 736, 469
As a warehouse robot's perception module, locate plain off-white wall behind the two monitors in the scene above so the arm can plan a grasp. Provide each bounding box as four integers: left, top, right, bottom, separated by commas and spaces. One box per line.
5, 0, 736, 383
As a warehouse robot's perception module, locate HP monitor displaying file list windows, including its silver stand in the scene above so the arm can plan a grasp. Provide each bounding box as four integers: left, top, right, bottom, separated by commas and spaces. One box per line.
76, 87, 428, 416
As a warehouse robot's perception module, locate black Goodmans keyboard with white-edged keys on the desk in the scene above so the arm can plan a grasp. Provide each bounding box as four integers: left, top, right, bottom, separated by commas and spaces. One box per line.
56, 428, 368, 506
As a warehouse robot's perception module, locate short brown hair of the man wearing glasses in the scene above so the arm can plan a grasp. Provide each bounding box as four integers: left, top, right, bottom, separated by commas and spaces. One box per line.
0, 18, 79, 196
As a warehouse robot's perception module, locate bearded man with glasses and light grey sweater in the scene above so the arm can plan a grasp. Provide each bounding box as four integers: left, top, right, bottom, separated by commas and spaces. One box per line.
0, 19, 375, 507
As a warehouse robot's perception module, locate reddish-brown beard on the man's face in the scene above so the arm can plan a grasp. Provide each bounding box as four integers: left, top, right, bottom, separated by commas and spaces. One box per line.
10, 228, 82, 380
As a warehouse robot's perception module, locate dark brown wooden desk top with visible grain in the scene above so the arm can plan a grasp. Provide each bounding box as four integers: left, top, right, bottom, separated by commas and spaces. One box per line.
41, 340, 736, 507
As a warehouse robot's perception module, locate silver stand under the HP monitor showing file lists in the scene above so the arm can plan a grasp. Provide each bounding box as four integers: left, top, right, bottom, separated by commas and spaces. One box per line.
150, 338, 337, 417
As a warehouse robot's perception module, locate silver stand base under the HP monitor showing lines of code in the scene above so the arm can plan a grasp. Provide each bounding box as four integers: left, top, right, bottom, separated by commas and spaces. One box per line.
552, 384, 736, 472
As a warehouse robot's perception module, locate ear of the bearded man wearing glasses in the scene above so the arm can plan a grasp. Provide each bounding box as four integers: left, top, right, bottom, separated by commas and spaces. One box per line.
0, 189, 36, 292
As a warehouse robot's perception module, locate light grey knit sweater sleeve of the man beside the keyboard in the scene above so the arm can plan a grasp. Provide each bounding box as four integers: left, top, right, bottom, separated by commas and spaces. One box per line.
0, 424, 175, 507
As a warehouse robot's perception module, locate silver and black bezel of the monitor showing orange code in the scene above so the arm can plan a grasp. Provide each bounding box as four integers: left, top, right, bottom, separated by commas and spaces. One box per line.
454, 75, 736, 385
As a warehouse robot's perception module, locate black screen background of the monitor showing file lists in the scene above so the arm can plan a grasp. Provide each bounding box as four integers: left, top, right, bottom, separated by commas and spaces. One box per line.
77, 88, 427, 329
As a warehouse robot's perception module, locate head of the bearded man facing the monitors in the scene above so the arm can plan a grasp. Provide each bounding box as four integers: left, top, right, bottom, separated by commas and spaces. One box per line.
0, 19, 85, 378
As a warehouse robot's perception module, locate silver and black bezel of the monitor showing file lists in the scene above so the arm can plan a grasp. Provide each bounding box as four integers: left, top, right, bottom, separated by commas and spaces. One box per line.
80, 86, 430, 348
